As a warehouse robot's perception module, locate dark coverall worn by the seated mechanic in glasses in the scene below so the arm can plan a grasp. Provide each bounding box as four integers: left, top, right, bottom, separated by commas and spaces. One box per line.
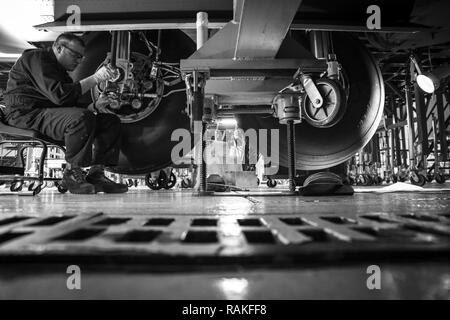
4, 48, 121, 167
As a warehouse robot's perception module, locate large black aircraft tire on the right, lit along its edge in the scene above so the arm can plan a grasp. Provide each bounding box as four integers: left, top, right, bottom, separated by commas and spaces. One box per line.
238, 32, 385, 170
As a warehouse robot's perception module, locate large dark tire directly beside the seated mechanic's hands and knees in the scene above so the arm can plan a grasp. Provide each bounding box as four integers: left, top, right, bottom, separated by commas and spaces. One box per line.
73, 30, 196, 175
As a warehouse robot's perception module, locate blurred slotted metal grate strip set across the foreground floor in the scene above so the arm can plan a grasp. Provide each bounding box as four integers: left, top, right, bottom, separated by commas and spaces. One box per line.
0, 213, 450, 262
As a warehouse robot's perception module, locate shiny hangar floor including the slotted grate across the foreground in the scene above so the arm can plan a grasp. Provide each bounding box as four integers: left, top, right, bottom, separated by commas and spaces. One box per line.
0, 183, 450, 299
